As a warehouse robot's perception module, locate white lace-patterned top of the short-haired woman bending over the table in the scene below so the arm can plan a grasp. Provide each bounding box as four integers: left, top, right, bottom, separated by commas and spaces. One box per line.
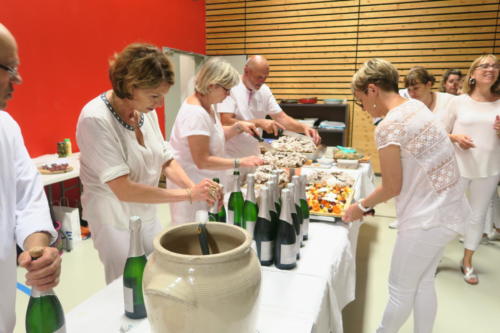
375, 100, 470, 233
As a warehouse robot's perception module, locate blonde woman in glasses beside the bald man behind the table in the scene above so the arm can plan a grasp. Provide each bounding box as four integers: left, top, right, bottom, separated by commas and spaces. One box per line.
167, 58, 263, 224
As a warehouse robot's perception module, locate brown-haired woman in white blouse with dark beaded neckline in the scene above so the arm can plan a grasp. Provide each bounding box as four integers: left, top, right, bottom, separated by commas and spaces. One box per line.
76, 44, 218, 283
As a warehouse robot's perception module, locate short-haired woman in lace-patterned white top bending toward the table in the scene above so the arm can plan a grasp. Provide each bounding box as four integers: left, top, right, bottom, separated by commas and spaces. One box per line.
343, 59, 470, 333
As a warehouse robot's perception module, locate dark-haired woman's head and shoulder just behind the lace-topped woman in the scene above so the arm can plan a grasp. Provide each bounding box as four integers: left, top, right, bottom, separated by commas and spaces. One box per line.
405, 66, 454, 115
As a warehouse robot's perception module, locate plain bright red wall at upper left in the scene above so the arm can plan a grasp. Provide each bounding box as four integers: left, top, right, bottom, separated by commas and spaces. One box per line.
0, 0, 205, 157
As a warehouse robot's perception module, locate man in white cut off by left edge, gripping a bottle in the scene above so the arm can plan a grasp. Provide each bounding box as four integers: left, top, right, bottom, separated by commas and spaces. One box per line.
0, 23, 61, 332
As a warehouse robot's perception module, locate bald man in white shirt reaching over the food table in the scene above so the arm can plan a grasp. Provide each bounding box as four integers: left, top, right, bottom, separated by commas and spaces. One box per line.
216, 55, 320, 158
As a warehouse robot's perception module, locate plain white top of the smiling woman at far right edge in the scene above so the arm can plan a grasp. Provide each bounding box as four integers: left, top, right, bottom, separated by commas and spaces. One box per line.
443, 94, 500, 179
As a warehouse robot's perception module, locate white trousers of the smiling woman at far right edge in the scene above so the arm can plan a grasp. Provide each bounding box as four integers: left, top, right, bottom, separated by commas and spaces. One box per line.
464, 175, 500, 251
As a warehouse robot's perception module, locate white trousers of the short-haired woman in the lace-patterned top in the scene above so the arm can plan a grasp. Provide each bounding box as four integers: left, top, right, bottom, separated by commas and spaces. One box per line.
377, 227, 458, 333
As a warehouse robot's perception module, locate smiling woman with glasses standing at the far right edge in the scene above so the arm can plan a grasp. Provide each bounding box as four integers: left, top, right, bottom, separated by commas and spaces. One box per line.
443, 54, 500, 284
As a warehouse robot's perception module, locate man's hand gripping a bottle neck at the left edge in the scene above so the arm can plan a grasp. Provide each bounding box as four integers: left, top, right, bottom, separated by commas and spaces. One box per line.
19, 247, 61, 291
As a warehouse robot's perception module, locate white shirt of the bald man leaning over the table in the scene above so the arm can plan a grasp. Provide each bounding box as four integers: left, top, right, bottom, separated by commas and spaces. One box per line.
216, 80, 283, 157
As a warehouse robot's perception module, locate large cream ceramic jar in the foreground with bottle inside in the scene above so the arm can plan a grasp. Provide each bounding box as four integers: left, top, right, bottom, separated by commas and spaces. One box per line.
143, 222, 261, 333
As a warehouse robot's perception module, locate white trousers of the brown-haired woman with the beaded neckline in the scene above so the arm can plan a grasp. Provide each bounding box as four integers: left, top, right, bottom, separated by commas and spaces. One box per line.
88, 219, 162, 284
